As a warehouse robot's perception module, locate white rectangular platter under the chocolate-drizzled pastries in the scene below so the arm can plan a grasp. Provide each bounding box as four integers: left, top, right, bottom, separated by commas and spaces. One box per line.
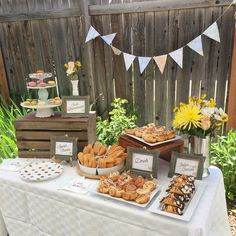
148, 180, 207, 221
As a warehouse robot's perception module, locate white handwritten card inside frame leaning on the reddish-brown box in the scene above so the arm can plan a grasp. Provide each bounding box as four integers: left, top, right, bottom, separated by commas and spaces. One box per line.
132, 153, 153, 171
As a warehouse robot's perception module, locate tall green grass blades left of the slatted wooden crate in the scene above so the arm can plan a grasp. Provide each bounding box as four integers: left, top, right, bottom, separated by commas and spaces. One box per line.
0, 97, 28, 163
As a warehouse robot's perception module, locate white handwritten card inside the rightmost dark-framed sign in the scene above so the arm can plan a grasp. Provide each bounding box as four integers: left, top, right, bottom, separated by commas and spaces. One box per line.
175, 158, 199, 177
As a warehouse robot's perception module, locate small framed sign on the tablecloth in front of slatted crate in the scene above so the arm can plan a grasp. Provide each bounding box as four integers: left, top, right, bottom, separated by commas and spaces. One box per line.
50, 136, 78, 163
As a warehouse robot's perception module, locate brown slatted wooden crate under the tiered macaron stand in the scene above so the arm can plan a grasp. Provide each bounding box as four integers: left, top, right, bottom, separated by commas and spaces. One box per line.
14, 112, 96, 158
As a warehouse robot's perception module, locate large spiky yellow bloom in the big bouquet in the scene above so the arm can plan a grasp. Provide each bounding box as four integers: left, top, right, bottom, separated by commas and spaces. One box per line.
173, 103, 203, 130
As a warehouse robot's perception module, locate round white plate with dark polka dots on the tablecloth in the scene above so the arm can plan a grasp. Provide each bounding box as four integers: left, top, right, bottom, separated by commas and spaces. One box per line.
20, 161, 63, 182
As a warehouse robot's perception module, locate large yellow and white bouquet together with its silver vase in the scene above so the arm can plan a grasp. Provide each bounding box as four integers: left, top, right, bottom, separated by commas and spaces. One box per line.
173, 94, 228, 177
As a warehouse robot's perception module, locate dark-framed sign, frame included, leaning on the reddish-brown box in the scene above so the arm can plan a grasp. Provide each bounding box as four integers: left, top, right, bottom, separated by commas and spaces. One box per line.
126, 147, 160, 178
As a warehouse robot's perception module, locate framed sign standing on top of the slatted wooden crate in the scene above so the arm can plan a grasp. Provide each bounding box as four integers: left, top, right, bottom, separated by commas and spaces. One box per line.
62, 96, 89, 117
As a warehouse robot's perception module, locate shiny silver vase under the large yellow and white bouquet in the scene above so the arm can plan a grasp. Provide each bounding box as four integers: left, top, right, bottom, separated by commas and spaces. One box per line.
191, 136, 211, 178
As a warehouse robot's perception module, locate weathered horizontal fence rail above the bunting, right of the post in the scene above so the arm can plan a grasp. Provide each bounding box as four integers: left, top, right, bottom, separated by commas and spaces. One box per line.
89, 0, 231, 16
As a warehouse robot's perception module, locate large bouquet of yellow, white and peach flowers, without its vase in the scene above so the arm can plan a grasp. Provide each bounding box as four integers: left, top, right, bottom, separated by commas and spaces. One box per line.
173, 95, 228, 138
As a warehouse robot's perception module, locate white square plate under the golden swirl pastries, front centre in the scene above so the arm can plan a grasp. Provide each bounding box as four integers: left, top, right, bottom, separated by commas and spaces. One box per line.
90, 184, 161, 208
